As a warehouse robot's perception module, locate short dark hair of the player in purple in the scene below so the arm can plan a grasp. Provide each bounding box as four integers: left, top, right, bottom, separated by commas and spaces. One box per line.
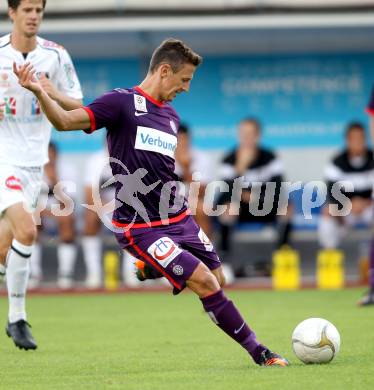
149, 38, 203, 73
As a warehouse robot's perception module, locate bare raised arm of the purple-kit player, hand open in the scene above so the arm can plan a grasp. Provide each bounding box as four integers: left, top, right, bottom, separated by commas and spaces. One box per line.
13, 63, 91, 131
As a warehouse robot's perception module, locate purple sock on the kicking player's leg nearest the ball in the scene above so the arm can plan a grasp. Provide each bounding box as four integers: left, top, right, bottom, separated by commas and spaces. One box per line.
200, 290, 267, 363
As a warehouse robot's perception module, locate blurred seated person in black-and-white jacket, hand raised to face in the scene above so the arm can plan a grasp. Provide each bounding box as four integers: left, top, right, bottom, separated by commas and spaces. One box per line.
217, 118, 290, 253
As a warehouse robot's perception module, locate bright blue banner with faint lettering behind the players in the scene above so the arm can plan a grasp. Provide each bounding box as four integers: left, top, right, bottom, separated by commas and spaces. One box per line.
54, 54, 374, 151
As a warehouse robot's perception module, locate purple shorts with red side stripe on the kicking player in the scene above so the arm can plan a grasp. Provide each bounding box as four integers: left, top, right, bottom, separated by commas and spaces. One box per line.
115, 215, 221, 290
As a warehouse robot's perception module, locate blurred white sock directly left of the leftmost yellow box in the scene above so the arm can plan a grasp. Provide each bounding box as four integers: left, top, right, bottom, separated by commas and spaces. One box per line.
82, 236, 102, 280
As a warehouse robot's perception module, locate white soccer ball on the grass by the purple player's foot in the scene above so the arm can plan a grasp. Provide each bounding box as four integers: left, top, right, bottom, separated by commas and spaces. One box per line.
292, 318, 340, 364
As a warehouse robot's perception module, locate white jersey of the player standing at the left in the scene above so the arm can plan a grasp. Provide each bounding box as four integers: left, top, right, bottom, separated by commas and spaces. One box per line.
0, 34, 83, 167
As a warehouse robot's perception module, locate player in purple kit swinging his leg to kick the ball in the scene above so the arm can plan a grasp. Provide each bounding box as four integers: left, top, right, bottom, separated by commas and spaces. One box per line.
14, 39, 288, 366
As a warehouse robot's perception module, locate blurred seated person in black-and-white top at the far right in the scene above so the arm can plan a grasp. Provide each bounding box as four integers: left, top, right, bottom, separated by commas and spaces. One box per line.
318, 122, 374, 249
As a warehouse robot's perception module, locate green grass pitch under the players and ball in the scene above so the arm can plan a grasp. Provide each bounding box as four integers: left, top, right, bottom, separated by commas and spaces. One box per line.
0, 289, 374, 390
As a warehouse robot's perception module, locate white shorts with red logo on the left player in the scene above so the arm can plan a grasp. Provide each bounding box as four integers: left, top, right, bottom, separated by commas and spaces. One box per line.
0, 164, 43, 216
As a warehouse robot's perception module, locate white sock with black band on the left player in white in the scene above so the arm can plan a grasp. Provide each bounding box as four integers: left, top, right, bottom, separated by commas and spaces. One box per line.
7, 239, 32, 323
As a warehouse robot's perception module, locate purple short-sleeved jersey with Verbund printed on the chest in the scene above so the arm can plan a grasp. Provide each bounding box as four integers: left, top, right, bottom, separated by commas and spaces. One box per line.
85, 87, 186, 226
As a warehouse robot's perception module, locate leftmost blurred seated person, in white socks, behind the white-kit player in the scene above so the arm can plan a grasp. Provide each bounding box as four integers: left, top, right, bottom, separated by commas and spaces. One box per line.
29, 143, 77, 289
